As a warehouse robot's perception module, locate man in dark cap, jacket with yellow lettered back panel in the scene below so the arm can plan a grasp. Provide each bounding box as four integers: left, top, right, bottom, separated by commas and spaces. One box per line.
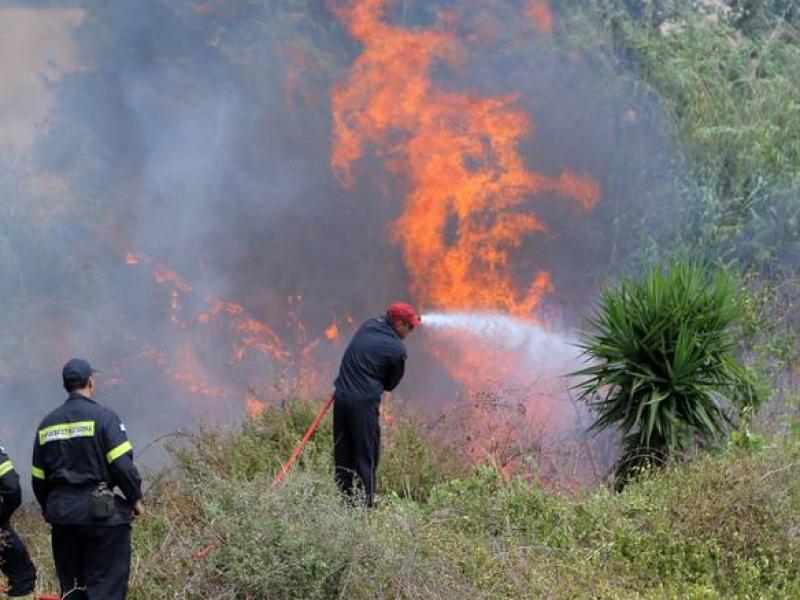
31, 359, 144, 600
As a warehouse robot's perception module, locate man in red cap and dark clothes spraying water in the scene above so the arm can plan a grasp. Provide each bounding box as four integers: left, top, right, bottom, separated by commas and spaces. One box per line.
333, 302, 422, 507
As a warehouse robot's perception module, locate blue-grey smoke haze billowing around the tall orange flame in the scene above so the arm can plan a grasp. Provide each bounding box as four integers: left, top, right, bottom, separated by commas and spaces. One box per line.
0, 0, 683, 486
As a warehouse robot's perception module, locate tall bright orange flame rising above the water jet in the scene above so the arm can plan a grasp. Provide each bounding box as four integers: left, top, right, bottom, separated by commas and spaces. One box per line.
331, 0, 600, 318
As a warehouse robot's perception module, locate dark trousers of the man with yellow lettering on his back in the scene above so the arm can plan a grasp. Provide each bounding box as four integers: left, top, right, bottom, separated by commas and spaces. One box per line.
52, 525, 131, 600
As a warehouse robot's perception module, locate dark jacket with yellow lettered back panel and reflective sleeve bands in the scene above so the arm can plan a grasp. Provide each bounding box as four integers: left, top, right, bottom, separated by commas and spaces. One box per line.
31, 394, 142, 525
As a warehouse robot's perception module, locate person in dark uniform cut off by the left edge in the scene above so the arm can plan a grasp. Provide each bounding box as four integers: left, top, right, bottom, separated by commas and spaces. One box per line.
0, 446, 36, 599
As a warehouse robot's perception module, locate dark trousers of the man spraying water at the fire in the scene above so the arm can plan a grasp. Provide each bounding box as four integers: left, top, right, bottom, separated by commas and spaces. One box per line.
333, 396, 381, 506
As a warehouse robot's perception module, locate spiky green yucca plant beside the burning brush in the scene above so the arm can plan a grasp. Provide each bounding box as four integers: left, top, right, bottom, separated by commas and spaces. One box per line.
571, 261, 759, 489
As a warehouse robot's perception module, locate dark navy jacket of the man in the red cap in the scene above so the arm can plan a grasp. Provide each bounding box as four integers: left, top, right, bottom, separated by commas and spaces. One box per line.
334, 318, 406, 401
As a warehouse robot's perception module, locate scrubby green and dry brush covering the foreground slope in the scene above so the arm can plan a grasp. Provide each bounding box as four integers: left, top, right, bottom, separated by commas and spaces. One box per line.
10, 403, 800, 598
